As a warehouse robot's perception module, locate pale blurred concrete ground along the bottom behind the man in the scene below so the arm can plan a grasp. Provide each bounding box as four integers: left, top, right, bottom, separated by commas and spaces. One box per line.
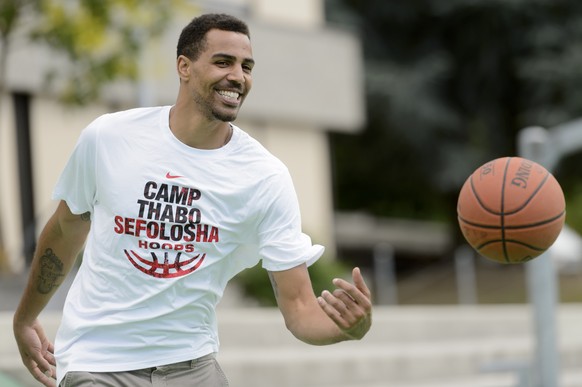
0, 270, 582, 387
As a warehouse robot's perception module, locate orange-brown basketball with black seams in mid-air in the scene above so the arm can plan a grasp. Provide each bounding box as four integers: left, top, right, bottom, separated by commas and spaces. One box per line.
457, 157, 566, 263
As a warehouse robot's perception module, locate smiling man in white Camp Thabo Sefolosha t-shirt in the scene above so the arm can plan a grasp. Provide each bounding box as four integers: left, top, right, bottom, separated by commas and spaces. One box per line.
14, 14, 371, 387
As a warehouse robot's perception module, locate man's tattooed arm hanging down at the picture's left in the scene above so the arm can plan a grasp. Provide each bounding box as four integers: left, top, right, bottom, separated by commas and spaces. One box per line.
13, 201, 91, 386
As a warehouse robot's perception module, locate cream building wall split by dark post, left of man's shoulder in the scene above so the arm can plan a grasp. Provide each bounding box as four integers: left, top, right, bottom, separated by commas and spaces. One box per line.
0, 95, 107, 271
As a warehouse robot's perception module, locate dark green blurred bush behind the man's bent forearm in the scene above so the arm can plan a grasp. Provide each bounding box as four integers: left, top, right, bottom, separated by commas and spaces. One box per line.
235, 258, 349, 306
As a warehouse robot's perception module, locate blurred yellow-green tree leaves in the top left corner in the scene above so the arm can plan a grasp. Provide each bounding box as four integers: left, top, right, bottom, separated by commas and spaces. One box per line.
0, 0, 197, 271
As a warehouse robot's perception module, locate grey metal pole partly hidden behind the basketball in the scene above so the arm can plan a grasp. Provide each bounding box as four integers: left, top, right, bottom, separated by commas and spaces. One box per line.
518, 127, 560, 387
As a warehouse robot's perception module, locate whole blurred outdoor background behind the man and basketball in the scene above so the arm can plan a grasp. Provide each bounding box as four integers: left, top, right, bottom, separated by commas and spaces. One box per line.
0, 0, 582, 387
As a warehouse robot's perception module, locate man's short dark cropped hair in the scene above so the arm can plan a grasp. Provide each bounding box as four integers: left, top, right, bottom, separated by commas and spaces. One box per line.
176, 13, 251, 60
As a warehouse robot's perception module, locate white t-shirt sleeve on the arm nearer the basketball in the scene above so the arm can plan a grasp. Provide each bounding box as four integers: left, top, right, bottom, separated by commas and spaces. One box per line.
258, 170, 324, 271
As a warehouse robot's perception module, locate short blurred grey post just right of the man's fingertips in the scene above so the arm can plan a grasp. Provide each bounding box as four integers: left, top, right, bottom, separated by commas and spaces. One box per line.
374, 243, 398, 305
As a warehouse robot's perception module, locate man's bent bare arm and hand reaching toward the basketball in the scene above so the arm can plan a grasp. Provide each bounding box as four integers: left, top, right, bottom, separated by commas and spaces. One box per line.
269, 264, 372, 345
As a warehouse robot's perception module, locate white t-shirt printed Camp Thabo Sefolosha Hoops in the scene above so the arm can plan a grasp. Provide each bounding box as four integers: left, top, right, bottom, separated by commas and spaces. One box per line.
53, 106, 323, 385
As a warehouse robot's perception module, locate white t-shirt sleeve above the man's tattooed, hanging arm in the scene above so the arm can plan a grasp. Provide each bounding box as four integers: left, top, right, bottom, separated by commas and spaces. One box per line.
52, 120, 97, 214
